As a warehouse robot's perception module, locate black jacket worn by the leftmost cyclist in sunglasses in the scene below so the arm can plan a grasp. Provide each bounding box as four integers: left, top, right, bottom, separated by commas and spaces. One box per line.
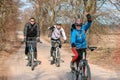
24, 22, 40, 37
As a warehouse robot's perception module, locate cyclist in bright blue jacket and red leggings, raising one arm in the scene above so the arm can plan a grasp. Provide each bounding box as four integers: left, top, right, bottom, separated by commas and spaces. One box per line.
70, 12, 92, 69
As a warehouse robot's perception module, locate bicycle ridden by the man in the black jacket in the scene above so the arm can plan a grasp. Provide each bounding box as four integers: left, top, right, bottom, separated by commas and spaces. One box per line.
25, 37, 40, 70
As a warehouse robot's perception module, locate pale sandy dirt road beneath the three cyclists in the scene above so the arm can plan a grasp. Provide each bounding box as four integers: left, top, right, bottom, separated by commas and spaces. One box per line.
2, 38, 120, 80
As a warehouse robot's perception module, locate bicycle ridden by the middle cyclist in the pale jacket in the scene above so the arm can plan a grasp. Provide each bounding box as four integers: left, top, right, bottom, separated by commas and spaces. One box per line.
51, 40, 61, 67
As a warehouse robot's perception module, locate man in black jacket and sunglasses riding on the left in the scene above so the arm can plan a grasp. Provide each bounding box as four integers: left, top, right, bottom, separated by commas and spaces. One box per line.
24, 18, 40, 60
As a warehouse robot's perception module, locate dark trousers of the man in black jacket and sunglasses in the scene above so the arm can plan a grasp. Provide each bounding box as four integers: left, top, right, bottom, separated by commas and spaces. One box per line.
25, 39, 37, 59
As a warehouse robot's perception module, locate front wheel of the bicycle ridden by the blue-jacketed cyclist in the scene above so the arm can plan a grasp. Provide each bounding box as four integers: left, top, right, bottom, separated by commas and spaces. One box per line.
81, 64, 91, 80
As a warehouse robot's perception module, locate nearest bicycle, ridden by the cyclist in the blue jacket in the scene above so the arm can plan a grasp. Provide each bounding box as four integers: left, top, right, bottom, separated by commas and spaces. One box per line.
71, 47, 97, 80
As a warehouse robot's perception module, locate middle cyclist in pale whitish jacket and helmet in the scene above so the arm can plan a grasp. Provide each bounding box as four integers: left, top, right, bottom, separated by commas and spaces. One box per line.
48, 22, 66, 64
